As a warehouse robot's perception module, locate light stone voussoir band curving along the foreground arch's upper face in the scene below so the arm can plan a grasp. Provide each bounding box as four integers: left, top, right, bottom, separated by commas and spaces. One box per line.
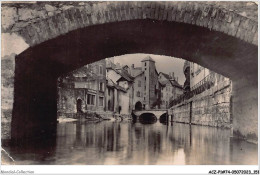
2, 1, 258, 46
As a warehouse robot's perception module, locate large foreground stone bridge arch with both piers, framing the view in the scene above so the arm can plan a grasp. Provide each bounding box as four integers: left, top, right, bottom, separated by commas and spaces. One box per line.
2, 2, 258, 142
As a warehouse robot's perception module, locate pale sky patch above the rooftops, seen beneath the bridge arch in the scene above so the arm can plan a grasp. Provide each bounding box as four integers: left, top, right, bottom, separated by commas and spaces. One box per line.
106, 53, 185, 85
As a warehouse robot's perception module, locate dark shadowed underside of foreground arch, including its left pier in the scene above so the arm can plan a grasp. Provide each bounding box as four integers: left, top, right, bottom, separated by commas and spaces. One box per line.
12, 19, 257, 142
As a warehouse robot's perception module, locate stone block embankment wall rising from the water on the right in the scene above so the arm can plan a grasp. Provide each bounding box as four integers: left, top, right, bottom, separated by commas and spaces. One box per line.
169, 81, 232, 128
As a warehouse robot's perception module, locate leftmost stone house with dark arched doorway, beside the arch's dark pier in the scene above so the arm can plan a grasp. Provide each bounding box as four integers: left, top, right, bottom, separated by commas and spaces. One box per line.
57, 60, 106, 116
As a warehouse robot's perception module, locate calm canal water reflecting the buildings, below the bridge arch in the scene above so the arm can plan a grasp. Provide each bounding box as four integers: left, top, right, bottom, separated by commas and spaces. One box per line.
2, 121, 258, 165
